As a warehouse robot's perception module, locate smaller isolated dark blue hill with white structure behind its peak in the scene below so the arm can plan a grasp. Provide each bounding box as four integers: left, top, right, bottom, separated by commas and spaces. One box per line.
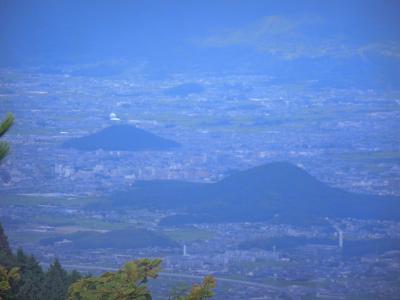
62, 125, 180, 151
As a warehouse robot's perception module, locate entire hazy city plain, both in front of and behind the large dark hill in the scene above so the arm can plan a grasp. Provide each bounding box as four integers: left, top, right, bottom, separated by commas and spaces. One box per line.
0, 65, 400, 299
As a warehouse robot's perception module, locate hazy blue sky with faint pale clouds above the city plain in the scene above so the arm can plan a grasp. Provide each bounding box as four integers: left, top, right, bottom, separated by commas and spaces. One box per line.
0, 0, 400, 84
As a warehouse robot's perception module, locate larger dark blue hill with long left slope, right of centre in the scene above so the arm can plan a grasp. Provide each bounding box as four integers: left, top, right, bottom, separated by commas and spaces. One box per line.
99, 162, 400, 224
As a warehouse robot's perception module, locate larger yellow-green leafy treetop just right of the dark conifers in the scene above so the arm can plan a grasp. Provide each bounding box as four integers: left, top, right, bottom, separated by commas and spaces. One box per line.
68, 259, 161, 300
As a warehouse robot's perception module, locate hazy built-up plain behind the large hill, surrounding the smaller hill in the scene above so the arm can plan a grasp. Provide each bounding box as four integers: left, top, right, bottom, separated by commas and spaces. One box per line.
0, 66, 400, 194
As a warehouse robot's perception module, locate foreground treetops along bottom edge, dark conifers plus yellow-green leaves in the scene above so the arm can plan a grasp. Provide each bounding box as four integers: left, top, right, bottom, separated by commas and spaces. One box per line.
0, 224, 215, 300
